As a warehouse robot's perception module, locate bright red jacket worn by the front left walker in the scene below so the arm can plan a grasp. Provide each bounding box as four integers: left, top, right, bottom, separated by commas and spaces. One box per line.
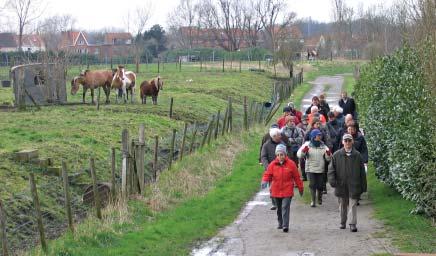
262, 157, 303, 198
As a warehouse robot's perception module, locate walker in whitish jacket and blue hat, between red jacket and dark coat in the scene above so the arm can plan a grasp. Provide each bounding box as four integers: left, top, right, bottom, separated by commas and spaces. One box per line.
297, 129, 332, 207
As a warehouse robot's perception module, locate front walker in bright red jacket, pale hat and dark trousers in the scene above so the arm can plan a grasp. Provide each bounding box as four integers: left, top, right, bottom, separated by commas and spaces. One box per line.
261, 144, 304, 232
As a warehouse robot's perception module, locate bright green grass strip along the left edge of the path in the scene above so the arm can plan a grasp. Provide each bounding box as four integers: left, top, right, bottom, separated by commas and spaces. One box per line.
34, 132, 262, 255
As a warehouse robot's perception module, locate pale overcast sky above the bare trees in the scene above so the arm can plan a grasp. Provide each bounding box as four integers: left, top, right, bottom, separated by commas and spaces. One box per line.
0, 0, 393, 32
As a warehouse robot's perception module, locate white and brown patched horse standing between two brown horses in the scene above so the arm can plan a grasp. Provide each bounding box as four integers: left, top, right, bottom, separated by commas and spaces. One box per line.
111, 66, 136, 103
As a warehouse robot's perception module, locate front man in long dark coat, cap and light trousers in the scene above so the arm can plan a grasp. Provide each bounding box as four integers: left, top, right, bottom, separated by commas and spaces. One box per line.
327, 134, 366, 232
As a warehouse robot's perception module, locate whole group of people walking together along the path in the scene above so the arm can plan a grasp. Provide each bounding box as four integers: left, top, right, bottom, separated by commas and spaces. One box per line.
259, 92, 368, 232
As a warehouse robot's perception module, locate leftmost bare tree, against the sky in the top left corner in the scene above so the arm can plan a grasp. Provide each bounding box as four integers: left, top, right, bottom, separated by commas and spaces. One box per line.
7, 0, 46, 51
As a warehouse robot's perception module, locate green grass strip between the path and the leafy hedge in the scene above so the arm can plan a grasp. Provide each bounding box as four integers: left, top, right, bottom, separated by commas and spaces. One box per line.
367, 166, 436, 253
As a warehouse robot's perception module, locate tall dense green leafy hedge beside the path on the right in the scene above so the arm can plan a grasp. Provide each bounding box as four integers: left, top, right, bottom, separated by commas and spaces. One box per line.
355, 46, 436, 218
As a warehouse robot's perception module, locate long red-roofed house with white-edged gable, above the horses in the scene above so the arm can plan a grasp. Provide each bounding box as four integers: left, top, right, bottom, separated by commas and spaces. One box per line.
60, 31, 133, 59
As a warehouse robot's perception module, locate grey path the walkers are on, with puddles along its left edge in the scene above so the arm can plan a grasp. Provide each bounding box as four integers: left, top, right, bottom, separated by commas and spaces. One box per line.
191, 76, 395, 256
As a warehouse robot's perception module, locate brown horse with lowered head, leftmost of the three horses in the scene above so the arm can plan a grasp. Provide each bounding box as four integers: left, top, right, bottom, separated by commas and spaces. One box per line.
71, 70, 113, 104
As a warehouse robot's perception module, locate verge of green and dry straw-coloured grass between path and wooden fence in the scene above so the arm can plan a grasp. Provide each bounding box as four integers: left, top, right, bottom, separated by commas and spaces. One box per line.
32, 129, 262, 255
